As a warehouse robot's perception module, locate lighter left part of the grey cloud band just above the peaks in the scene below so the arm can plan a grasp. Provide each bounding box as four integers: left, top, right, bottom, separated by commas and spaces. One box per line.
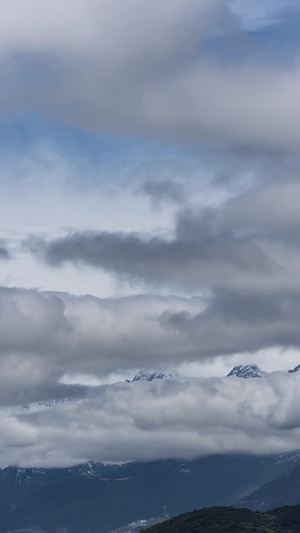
0, 288, 204, 405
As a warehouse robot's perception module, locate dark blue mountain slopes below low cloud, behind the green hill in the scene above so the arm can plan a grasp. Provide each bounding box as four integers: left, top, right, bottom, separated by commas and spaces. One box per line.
0, 452, 300, 533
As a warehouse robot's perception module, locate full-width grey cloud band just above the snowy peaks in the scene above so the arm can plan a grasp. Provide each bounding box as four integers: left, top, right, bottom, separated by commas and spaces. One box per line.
0, 282, 300, 412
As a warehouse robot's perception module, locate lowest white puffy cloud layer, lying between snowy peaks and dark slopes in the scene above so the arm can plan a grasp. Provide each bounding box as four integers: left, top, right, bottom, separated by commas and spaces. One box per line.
0, 373, 300, 467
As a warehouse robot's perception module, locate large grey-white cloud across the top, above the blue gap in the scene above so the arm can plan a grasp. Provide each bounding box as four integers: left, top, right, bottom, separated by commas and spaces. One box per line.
0, 0, 300, 151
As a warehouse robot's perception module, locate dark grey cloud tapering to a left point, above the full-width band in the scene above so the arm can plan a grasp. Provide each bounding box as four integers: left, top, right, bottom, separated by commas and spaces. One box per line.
26, 168, 300, 293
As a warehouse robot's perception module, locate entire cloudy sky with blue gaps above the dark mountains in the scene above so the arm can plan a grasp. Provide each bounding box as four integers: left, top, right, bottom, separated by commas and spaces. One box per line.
0, 0, 300, 466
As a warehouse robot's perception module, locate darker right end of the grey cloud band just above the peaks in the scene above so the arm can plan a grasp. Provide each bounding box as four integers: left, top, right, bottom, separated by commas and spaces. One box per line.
160, 289, 300, 357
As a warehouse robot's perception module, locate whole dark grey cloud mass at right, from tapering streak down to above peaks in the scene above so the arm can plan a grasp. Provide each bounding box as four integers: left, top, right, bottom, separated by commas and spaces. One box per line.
23, 171, 300, 366
